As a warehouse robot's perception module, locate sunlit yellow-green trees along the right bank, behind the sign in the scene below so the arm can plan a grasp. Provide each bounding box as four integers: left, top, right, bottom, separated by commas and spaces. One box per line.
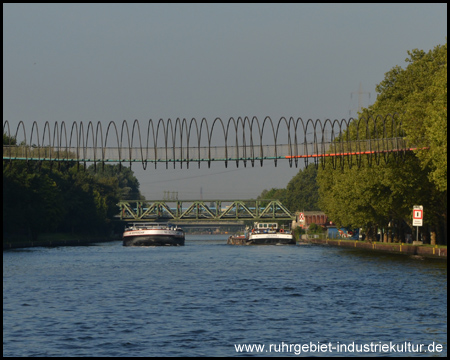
260, 44, 447, 244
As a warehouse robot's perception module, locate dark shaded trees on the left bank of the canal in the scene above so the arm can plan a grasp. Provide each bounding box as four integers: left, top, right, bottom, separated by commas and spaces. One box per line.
3, 134, 141, 240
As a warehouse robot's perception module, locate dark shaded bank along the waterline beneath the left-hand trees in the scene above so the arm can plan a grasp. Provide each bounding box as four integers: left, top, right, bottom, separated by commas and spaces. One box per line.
3, 234, 116, 250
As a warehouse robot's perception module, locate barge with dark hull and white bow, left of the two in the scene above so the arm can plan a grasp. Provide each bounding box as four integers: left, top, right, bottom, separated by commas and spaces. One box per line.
122, 223, 184, 246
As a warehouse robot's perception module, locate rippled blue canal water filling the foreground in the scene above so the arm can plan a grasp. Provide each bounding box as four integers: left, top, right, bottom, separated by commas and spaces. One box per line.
3, 235, 447, 357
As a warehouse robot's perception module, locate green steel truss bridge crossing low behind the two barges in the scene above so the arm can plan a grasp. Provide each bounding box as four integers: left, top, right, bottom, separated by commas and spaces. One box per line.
117, 200, 295, 225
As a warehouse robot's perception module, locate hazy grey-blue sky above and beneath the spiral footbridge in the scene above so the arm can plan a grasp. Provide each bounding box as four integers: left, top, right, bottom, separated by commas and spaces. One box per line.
3, 3, 447, 200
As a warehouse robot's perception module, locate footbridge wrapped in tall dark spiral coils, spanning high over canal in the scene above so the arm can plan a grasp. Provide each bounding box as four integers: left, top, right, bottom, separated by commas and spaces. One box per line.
3, 115, 422, 169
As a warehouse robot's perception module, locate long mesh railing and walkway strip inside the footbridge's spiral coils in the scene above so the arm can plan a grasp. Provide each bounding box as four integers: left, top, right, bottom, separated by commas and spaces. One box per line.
3, 138, 406, 163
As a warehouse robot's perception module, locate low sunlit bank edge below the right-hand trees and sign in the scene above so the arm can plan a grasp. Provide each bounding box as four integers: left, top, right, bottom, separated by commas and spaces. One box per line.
301, 239, 447, 260
